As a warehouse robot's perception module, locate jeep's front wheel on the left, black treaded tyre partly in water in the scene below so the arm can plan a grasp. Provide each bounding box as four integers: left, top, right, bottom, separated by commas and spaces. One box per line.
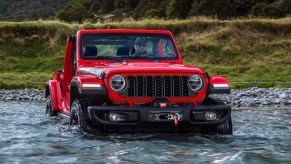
69, 99, 93, 133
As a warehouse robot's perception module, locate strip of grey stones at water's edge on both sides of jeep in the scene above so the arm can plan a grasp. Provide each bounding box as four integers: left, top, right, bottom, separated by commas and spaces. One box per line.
0, 88, 291, 107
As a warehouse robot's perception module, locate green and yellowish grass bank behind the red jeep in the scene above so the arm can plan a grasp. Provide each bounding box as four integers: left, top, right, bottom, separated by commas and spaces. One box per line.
0, 18, 291, 89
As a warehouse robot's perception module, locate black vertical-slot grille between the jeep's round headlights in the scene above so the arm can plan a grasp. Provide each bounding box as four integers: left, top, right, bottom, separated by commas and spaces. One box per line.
127, 76, 189, 98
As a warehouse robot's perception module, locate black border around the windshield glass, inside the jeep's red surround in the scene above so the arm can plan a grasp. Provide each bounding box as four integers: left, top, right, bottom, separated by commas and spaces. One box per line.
78, 33, 179, 61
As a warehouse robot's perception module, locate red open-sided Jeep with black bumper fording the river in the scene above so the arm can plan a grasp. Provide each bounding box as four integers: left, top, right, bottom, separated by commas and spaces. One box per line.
45, 30, 232, 134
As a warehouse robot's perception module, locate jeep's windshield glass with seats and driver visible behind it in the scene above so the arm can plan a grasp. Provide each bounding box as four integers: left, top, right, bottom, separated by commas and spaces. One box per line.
81, 33, 178, 60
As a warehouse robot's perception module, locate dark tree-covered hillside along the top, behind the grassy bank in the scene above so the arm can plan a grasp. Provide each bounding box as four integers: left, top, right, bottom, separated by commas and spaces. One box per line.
0, 0, 291, 22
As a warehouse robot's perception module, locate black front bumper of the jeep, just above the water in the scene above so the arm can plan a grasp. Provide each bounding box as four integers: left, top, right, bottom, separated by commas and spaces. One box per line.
88, 105, 231, 132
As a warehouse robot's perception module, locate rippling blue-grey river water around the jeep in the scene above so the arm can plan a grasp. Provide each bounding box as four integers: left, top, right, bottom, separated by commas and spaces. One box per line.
0, 102, 291, 164
